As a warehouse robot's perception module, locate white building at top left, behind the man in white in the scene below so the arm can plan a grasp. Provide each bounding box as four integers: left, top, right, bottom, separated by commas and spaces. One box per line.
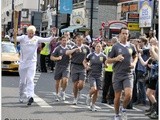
1, 0, 42, 34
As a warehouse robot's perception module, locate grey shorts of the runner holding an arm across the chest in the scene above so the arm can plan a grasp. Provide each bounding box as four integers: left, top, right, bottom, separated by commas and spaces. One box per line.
71, 72, 86, 82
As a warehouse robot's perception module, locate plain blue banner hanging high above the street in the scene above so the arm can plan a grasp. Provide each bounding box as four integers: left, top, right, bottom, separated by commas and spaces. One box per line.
60, 0, 73, 14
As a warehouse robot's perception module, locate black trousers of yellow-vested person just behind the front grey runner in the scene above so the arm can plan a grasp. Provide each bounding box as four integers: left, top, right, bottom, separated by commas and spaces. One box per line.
102, 71, 114, 100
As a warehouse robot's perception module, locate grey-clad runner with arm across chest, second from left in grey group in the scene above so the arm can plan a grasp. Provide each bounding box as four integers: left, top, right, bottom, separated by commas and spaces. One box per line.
66, 35, 90, 105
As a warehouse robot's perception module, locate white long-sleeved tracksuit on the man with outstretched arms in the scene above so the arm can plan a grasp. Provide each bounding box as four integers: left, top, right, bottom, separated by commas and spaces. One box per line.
17, 35, 52, 98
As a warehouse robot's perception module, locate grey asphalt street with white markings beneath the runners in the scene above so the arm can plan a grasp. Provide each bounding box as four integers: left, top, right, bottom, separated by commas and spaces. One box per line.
2, 73, 149, 120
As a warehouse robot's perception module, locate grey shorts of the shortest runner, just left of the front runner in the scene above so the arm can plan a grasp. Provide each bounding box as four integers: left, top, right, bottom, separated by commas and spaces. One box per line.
89, 77, 102, 90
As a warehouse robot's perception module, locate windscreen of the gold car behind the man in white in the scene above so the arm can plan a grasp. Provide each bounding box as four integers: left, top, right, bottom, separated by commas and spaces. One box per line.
2, 44, 17, 53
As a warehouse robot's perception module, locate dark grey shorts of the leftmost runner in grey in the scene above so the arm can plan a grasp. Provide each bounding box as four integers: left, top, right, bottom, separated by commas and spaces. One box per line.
54, 67, 69, 80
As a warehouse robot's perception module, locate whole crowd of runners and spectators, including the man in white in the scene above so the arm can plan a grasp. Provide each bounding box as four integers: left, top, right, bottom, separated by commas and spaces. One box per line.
13, 26, 159, 120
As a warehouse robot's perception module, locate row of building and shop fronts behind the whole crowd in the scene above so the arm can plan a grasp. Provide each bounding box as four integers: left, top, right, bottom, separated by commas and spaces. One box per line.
1, 0, 158, 37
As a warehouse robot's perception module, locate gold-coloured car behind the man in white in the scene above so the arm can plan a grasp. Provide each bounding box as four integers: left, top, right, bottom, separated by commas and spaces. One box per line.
1, 42, 20, 72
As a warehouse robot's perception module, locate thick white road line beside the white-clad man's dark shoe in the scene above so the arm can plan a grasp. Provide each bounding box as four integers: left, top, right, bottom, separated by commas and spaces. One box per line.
34, 95, 53, 108
